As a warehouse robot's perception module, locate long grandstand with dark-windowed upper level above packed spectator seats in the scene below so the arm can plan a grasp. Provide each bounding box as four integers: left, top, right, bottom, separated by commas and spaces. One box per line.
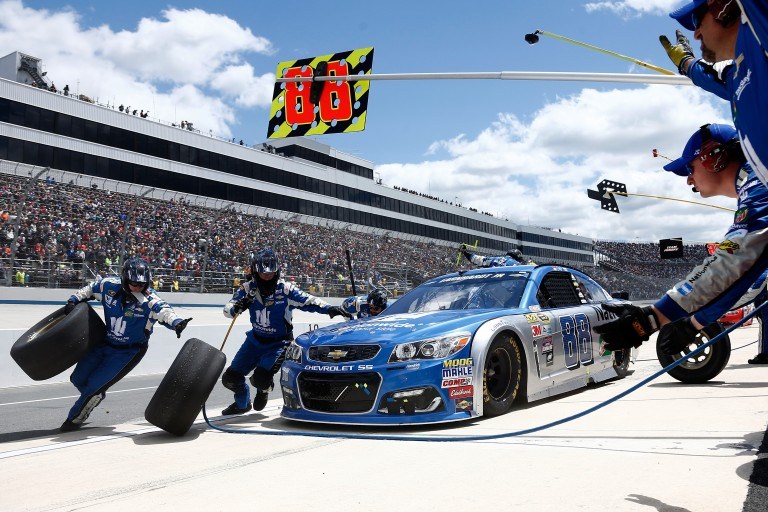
0, 52, 708, 297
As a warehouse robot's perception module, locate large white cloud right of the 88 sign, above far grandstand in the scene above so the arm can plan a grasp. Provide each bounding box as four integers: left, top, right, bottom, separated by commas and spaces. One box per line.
376, 85, 735, 241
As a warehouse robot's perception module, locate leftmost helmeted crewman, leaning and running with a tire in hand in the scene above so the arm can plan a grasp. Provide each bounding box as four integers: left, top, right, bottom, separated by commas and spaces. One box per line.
59, 257, 192, 432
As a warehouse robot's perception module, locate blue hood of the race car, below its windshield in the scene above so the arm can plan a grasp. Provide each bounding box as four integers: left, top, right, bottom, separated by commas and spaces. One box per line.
296, 309, 528, 346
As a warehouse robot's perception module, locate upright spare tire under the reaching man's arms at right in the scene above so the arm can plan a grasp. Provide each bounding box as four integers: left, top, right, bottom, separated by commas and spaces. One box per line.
656, 322, 731, 384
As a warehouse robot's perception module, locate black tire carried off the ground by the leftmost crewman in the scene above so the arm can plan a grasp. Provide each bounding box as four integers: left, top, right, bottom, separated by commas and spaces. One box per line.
11, 302, 107, 380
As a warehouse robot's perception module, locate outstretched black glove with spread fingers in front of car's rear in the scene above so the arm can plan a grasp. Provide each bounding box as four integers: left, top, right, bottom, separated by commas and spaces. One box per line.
595, 304, 659, 352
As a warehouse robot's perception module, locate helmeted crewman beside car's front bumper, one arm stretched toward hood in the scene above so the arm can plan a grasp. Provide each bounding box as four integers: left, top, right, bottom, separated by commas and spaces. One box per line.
221, 249, 351, 416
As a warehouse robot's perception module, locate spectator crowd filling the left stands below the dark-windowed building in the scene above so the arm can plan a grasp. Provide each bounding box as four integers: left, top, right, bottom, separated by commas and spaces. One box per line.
0, 175, 464, 287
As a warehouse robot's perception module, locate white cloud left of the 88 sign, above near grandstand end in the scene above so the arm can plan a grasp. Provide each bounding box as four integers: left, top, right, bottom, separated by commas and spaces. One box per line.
0, 0, 274, 138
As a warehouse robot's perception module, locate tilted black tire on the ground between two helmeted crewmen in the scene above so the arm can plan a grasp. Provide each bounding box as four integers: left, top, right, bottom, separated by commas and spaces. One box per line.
144, 338, 227, 436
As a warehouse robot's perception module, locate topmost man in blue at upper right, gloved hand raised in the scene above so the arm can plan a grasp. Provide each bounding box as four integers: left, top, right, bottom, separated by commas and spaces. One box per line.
659, 0, 768, 186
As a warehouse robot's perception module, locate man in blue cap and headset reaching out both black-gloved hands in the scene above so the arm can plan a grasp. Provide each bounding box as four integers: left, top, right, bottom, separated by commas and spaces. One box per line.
595, 124, 768, 360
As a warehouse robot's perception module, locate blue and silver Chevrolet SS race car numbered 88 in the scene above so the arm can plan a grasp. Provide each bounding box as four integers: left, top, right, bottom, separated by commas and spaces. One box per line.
280, 265, 634, 425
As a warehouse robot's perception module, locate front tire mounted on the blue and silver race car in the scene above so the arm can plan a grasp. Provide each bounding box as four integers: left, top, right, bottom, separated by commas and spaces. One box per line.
483, 335, 523, 416
